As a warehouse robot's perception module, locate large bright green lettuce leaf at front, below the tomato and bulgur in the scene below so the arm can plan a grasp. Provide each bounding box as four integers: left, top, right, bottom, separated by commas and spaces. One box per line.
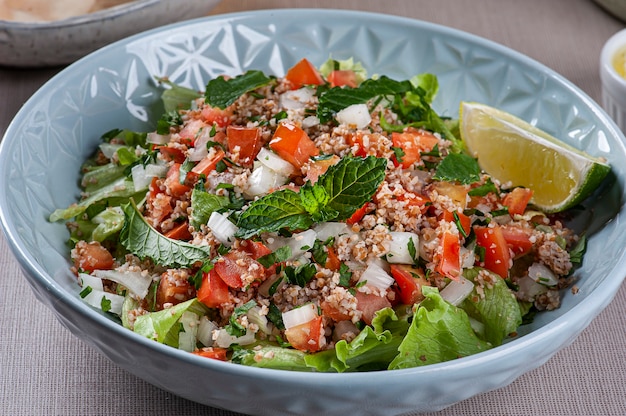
389, 287, 491, 370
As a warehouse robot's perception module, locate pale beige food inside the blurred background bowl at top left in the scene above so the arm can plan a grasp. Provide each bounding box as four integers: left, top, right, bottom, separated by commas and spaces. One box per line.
0, 0, 131, 22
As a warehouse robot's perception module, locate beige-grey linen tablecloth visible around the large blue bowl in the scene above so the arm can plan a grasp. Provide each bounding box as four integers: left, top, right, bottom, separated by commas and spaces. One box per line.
0, 0, 626, 416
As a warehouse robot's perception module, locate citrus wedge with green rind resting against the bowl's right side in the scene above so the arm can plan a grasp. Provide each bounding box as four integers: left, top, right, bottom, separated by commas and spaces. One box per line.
459, 102, 611, 213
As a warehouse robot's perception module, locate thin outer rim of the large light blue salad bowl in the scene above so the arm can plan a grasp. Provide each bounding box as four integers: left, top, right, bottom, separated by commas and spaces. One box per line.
0, 5, 626, 385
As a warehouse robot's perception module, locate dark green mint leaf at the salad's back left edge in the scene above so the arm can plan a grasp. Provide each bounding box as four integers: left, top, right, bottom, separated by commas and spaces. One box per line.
204, 71, 271, 109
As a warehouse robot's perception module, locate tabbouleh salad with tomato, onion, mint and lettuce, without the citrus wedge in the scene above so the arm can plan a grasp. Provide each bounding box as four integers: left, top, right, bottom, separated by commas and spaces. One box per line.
50, 59, 596, 372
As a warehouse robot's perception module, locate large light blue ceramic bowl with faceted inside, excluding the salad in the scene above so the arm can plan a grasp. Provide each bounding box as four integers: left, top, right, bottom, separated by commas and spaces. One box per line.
0, 10, 626, 416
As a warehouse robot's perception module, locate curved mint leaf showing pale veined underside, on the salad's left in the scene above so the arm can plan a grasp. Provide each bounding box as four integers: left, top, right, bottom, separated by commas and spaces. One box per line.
120, 200, 210, 267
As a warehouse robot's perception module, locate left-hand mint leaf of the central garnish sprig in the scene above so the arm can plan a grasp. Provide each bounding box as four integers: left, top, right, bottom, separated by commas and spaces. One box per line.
236, 189, 313, 238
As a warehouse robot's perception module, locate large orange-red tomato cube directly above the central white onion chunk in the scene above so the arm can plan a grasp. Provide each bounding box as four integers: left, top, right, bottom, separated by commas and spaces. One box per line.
270, 123, 320, 169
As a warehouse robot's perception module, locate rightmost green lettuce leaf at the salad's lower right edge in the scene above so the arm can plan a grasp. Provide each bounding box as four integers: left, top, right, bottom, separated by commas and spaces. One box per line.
460, 267, 522, 346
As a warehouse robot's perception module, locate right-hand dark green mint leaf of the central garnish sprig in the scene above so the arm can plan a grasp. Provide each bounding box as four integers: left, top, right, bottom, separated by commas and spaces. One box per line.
313, 156, 387, 221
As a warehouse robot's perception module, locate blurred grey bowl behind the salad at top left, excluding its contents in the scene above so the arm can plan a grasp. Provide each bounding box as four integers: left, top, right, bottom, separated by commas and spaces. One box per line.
0, 0, 220, 67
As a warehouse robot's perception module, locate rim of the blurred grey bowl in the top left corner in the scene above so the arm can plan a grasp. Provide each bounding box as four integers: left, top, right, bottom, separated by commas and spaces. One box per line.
0, 0, 162, 31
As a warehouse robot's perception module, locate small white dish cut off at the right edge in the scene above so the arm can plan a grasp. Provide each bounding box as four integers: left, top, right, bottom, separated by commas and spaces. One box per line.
600, 29, 626, 132
